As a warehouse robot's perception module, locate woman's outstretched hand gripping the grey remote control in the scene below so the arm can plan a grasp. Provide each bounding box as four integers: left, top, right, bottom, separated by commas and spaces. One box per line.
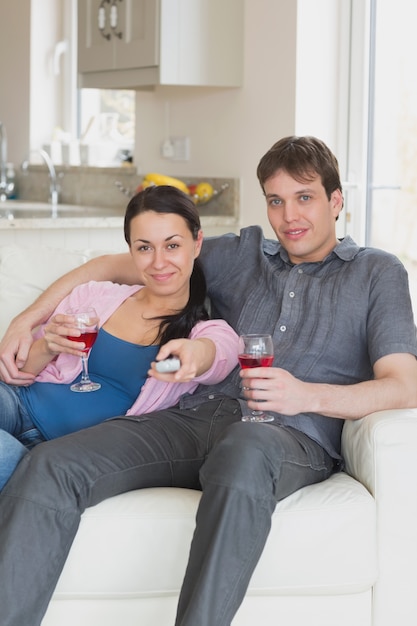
148, 337, 216, 383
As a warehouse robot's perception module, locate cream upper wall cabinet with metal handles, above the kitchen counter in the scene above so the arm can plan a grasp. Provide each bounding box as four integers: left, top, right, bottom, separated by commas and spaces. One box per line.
78, 0, 244, 89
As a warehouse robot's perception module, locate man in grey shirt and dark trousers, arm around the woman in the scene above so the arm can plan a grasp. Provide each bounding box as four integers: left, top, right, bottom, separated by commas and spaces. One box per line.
0, 137, 417, 626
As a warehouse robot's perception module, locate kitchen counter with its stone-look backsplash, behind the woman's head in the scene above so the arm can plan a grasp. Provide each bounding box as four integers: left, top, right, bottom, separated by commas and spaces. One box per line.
0, 165, 239, 251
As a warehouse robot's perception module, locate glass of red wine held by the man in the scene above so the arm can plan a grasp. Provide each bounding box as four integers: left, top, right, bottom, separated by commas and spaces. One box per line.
238, 334, 274, 422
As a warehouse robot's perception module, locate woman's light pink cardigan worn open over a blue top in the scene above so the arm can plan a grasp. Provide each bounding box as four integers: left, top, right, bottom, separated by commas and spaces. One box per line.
35, 281, 238, 417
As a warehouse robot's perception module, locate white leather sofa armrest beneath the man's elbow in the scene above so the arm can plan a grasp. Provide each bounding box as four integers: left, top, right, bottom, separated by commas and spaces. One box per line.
342, 409, 417, 626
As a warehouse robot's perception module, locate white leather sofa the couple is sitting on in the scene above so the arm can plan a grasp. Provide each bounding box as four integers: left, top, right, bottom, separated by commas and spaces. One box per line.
0, 246, 417, 626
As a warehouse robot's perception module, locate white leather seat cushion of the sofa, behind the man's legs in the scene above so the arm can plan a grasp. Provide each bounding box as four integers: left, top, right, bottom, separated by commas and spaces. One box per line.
55, 473, 377, 599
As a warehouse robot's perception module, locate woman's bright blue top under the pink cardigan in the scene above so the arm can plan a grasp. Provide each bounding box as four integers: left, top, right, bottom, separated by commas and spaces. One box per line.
22, 328, 159, 439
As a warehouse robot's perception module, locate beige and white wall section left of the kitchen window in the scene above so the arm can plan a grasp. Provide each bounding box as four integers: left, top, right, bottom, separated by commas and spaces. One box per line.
0, 0, 67, 164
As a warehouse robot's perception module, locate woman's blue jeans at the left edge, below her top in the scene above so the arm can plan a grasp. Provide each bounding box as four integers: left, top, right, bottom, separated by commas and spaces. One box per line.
0, 381, 44, 491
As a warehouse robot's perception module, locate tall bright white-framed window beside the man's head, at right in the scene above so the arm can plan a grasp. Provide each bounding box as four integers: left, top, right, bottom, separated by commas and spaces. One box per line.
347, 0, 417, 312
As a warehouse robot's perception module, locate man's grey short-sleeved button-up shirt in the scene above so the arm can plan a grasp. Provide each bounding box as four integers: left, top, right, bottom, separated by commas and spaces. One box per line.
181, 226, 417, 458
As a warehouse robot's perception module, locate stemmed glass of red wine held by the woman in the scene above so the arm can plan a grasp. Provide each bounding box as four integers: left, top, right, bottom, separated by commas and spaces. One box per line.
66, 307, 101, 392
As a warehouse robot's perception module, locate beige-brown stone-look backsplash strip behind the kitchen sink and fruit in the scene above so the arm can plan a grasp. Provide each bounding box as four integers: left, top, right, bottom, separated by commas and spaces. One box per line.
17, 165, 239, 218
